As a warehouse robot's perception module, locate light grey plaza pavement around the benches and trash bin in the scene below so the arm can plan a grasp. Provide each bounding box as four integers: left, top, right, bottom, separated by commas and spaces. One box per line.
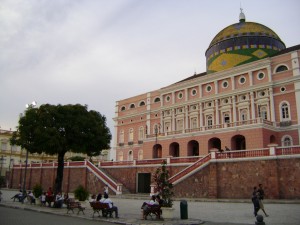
0, 189, 300, 225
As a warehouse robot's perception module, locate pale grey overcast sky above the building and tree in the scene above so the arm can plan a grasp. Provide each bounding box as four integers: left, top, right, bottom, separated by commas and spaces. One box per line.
0, 0, 300, 144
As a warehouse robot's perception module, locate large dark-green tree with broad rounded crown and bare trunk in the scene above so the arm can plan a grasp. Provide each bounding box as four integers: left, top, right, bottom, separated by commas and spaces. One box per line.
11, 104, 111, 192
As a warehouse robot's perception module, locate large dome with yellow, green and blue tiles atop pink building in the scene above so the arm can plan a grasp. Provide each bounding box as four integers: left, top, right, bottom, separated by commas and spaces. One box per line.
205, 11, 285, 73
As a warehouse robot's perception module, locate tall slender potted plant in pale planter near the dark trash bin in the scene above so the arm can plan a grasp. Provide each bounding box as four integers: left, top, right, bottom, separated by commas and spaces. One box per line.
153, 160, 174, 218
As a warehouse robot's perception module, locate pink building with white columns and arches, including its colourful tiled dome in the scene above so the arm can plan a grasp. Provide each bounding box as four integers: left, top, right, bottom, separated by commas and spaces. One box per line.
114, 13, 300, 161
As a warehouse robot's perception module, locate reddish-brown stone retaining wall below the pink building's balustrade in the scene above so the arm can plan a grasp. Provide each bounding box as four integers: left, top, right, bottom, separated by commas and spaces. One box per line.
10, 158, 300, 199
